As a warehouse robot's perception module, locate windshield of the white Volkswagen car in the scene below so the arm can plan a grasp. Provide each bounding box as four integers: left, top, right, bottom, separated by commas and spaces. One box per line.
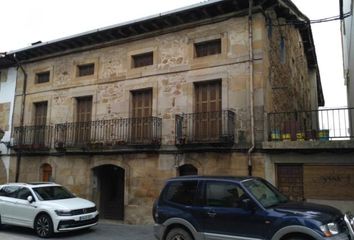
33, 186, 75, 201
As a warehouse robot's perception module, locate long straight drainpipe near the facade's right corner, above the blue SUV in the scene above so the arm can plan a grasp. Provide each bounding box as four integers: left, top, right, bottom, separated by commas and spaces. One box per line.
248, 0, 255, 176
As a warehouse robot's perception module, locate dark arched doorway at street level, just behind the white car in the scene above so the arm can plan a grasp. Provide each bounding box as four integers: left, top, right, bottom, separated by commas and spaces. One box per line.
93, 164, 125, 220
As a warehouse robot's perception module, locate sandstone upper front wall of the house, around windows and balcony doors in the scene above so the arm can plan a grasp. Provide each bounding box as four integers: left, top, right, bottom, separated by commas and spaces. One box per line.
14, 15, 264, 145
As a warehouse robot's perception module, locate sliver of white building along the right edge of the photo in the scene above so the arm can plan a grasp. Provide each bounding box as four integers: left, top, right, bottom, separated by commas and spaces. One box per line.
340, 0, 354, 136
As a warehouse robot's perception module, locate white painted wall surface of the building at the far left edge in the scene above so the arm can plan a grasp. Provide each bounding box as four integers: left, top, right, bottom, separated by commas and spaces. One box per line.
0, 68, 17, 181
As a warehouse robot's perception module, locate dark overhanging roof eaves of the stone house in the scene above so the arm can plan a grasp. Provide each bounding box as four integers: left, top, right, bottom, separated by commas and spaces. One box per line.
0, 0, 324, 105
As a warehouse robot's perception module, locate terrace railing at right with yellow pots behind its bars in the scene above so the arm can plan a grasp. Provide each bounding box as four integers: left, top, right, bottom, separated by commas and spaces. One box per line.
268, 108, 354, 141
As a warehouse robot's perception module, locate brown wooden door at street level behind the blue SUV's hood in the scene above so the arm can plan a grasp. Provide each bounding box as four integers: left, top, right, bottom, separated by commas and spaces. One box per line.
277, 164, 304, 201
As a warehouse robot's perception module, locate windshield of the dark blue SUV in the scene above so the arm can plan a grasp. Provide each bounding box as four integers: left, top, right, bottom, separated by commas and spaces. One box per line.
243, 179, 288, 208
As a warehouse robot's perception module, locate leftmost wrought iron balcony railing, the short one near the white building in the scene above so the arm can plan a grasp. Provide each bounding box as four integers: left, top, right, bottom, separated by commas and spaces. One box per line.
13, 126, 53, 151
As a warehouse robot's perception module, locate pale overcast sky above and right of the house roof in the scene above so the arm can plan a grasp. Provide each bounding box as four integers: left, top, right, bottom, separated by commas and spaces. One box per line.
0, 0, 346, 107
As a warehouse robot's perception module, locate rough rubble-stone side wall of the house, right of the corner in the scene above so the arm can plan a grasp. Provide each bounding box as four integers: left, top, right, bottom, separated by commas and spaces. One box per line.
265, 12, 317, 112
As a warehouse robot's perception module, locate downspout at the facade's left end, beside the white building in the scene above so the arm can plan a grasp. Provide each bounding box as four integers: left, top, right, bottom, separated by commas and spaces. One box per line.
13, 54, 27, 182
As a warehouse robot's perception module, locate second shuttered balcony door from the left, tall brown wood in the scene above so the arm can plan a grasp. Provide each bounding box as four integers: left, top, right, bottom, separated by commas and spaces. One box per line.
75, 96, 92, 144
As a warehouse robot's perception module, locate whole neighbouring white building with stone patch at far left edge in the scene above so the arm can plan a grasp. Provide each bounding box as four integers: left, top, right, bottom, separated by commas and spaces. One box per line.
0, 68, 17, 184
